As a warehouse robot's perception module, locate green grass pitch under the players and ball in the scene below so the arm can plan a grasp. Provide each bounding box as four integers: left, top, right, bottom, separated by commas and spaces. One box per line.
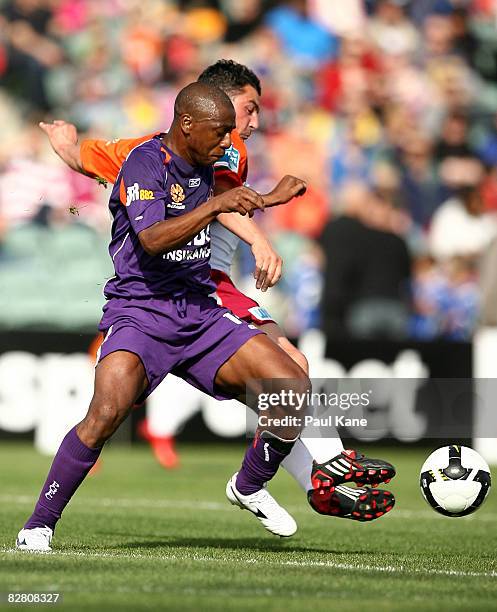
0, 443, 497, 612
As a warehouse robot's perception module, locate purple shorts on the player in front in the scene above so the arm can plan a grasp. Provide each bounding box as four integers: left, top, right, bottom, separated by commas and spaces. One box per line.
97, 294, 261, 401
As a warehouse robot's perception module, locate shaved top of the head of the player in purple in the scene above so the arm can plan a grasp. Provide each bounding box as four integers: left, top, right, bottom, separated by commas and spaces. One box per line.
174, 82, 234, 121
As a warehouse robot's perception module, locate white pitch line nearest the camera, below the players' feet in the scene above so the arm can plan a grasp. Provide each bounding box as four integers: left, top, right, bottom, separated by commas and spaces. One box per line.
0, 548, 497, 578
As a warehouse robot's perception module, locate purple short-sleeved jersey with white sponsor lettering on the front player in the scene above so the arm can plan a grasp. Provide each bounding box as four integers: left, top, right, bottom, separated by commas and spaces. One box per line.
104, 135, 215, 298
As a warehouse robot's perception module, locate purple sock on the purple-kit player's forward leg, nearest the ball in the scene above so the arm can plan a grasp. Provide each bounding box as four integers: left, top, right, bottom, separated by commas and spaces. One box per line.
236, 438, 295, 495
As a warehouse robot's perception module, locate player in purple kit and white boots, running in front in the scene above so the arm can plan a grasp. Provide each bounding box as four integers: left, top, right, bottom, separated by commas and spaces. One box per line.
16, 82, 316, 551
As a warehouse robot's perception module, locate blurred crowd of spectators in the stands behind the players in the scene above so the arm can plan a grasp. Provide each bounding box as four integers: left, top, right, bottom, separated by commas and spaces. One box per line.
0, 0, 497, 340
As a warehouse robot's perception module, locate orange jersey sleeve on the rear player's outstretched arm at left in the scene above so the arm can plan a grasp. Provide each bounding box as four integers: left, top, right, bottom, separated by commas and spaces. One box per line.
80, 132, 160, 183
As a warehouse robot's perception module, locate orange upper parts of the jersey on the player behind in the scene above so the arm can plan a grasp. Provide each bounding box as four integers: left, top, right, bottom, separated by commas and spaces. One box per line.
80, 130, 248, 187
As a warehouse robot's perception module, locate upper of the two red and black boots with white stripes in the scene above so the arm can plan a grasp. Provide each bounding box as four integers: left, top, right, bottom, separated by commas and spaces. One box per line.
311, 450, 395, 489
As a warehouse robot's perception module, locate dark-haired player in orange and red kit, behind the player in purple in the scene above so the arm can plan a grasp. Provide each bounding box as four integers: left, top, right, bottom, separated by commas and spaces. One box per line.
40, 59, 395, 521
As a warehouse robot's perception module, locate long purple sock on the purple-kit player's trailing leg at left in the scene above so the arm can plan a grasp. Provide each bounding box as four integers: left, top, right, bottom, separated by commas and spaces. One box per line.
24, 427, 102, 529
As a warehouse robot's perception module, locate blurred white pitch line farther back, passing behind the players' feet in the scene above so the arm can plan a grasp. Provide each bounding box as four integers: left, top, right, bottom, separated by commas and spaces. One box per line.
0, 495, 497, 523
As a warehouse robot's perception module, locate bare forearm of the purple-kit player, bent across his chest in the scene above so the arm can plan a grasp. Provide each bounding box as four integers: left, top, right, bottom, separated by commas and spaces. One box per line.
138, 198, 219, 255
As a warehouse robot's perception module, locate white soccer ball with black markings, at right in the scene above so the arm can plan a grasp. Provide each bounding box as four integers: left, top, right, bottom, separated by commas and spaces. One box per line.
419, 444, 491, 516
